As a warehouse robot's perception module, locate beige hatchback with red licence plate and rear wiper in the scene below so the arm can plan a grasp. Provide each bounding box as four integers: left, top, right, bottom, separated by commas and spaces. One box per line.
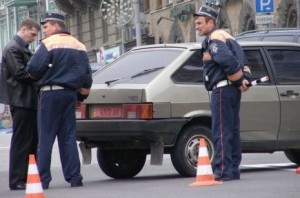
76, 41, 300, 178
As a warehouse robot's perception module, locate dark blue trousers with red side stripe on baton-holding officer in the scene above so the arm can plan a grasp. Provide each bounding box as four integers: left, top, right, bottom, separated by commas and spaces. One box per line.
211, 85, 242, 179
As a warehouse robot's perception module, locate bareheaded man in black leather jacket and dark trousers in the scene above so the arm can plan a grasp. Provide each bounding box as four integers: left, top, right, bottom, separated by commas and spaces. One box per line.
0, 19, 40, 190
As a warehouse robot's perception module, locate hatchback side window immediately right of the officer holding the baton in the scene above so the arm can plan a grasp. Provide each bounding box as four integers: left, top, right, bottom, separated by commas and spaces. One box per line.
244, 49, 268, 79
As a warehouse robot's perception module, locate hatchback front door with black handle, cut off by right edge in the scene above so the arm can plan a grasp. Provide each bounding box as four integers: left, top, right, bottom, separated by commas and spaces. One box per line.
266, 47, 300, 140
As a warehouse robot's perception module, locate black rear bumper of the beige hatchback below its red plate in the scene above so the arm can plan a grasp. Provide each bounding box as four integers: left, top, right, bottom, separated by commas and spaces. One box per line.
76, 118, 188, 145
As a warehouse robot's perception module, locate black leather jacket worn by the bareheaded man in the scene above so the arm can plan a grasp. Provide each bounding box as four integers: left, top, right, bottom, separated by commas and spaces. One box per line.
0, 36, 37, 109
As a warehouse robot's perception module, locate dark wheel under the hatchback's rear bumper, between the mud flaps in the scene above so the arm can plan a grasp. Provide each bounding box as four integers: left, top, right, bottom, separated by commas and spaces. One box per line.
97, 148, 146, 179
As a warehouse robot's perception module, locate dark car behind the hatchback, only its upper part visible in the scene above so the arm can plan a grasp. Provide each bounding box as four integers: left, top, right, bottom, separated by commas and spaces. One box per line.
235, 28, 300, 43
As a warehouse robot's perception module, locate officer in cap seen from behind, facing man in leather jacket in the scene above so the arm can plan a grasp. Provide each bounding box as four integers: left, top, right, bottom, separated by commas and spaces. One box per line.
27, 13, 92, 189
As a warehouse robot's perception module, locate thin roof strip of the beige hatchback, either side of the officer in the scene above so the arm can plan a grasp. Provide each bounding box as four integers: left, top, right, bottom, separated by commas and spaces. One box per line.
132, 41, 300, 51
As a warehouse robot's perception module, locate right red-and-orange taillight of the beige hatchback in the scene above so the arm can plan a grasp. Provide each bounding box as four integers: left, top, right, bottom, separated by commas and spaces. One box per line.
122, 104, 153, 119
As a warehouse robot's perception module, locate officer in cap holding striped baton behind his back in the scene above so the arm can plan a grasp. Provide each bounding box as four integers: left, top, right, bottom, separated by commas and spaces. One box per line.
194, 5, 250, 181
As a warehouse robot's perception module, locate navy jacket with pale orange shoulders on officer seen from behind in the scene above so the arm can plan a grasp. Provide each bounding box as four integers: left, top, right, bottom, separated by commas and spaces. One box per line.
27, 31, 92, 90
